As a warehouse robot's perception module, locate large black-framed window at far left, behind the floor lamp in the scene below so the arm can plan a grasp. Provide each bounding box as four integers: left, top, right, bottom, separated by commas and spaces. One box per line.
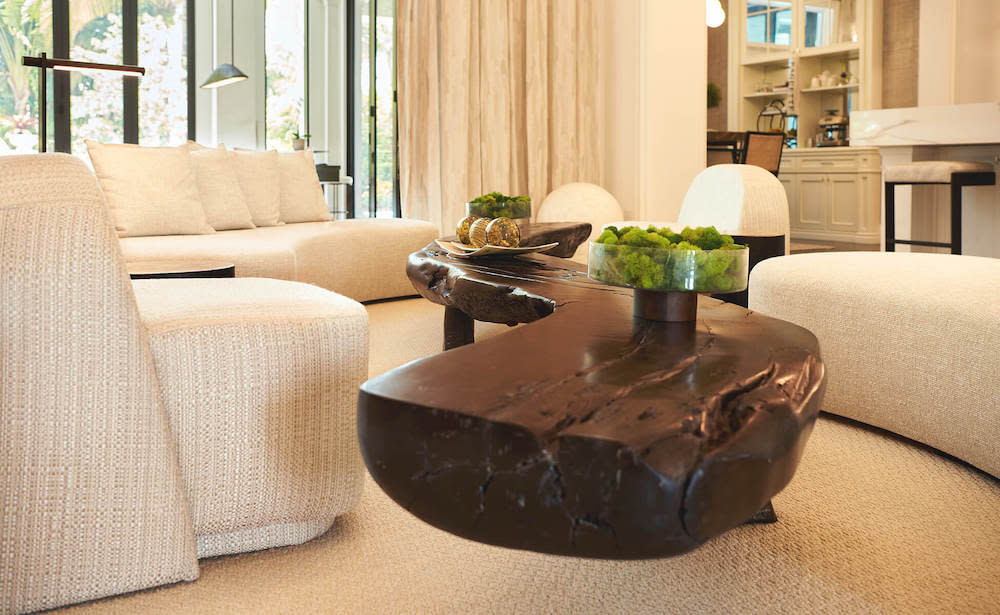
0, 0, 193, 155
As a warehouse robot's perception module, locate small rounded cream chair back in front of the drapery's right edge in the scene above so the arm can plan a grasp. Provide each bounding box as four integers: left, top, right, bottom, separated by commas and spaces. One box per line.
535, 182, 625, 263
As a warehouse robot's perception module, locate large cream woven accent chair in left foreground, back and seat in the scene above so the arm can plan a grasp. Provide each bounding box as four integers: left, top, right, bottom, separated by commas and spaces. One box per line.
0, 154, 368, 613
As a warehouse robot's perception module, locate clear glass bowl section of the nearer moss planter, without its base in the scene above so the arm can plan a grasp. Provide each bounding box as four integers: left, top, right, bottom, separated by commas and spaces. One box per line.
587, 241, 750, 293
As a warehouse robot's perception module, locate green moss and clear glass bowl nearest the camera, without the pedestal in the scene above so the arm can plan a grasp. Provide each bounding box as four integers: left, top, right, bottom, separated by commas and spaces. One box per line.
588, 226, 749, 292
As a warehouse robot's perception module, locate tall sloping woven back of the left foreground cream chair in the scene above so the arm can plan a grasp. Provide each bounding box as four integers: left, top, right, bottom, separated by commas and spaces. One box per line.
0, 154, 198, 613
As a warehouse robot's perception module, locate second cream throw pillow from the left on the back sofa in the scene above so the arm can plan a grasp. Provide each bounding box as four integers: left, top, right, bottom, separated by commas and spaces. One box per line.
188, 144, 254, 231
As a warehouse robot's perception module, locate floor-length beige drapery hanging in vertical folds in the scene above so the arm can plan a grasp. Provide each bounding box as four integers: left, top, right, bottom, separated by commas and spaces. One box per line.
396, 0, 603, 232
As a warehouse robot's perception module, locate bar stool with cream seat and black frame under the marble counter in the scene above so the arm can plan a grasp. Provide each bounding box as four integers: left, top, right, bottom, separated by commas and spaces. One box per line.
885, 160, 997, 254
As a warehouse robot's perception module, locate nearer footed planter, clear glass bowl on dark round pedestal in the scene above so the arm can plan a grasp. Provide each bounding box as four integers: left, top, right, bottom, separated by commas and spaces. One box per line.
587, 241, 750, 322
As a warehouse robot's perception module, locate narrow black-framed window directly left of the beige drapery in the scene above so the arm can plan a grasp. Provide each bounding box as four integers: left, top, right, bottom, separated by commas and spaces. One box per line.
348, 0, 400, 218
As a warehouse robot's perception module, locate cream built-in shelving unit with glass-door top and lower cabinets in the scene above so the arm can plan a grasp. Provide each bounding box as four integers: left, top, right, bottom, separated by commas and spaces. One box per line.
728, 0, 882, 243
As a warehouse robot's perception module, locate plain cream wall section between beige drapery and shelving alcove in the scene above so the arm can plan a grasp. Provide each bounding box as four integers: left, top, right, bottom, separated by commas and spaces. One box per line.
601, 0, 708, 222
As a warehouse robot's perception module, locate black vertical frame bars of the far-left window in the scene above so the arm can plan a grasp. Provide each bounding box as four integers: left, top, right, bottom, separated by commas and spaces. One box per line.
52, 0, 197, 154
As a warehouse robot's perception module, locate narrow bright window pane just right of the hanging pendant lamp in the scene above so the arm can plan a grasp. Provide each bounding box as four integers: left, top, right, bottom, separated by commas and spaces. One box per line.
264, 0, 307, 149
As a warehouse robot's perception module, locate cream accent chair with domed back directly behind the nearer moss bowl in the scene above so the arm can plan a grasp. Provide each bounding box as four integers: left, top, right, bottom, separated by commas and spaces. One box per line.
605, 164, 790, 254
